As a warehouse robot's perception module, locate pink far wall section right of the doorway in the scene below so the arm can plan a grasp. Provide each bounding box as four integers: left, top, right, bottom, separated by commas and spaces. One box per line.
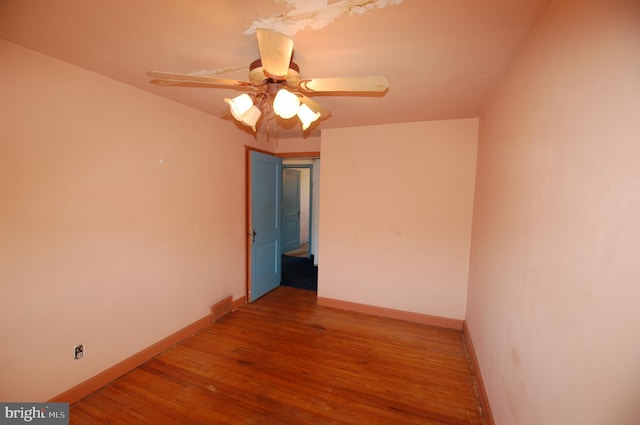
318, 119, 478, 319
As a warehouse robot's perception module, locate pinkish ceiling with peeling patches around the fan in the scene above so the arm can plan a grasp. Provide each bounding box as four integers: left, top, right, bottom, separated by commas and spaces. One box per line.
0, 0, 548, 138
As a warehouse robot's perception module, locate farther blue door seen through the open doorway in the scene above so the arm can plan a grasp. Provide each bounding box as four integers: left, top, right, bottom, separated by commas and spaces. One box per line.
282, 168, 300, 252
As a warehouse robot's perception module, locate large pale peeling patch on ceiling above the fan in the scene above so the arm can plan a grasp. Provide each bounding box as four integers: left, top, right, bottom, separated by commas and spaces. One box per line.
244, 0, 404, 37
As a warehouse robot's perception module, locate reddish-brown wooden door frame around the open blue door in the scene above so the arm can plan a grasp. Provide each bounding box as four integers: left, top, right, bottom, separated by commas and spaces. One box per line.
243, 145, 320, 302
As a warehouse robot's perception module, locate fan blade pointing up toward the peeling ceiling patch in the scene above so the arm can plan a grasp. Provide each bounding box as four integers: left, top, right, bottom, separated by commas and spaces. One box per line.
256, 28, 293, 80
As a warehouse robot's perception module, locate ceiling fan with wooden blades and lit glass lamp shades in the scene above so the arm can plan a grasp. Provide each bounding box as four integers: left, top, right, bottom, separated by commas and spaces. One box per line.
147, 29, 389, 132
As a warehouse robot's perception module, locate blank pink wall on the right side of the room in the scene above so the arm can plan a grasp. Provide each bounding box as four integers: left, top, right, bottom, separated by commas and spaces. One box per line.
467, 0, 640, 425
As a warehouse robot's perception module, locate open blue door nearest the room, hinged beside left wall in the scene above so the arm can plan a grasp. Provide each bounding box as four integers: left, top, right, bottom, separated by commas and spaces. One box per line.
249, 151, 282, 302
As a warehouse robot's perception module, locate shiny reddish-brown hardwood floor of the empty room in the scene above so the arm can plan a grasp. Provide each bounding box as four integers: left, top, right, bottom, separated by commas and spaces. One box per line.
70, 287, 484, 425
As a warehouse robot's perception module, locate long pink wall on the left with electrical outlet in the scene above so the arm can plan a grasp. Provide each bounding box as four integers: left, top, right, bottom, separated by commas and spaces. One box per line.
0, 41, 268, 401
